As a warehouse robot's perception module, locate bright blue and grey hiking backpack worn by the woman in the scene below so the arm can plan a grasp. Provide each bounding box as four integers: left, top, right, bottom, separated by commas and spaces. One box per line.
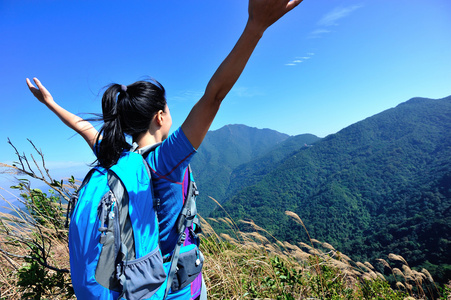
68, 151, 204, 300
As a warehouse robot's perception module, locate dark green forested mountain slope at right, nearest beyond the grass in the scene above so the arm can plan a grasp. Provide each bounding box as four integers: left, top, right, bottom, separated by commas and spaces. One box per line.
211, 96, 451, 278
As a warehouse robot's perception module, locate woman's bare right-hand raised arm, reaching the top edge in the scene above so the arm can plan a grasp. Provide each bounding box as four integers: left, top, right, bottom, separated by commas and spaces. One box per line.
182, 0, 302, 149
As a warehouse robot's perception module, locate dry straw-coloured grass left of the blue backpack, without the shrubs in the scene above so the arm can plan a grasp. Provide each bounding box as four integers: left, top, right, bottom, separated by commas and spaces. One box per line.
0, 197, 70, 299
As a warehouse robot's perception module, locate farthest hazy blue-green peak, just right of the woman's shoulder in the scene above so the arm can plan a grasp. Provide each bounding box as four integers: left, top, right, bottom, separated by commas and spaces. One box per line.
191, 125, 289, 215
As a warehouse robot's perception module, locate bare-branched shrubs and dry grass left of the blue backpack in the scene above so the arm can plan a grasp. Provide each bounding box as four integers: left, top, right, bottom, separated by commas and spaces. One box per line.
0, 141, 76, 299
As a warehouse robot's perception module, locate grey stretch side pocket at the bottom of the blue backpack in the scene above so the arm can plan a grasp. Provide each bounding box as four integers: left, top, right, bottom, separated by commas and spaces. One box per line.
123, 248, 166, 299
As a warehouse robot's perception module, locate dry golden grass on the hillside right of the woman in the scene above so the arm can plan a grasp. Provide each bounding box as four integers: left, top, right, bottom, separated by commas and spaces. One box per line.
201, 212, 444, 299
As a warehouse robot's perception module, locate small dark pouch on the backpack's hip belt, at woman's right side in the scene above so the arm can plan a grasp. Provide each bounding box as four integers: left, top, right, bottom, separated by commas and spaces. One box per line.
171, 246, 204, 292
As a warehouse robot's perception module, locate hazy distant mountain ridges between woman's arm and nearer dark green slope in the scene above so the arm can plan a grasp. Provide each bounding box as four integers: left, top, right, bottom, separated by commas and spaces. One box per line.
191, 125, 320, 216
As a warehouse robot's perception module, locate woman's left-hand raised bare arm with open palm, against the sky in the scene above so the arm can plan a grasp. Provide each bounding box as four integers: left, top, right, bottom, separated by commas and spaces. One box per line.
27, 78, 99, 148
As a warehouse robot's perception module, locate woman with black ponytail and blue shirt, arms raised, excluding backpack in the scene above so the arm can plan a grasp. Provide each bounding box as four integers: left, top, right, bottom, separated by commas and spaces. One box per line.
27, 0, 302, 299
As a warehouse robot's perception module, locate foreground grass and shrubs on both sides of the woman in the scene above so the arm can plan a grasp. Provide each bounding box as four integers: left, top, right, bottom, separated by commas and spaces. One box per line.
0, 141, 450, 299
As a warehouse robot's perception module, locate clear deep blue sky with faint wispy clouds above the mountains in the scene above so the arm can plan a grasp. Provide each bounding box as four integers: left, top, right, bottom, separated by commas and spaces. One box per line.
0, 0, 451, 186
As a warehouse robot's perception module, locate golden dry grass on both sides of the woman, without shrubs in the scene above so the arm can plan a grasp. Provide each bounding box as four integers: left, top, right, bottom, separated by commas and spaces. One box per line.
0, 191, 444, 299
